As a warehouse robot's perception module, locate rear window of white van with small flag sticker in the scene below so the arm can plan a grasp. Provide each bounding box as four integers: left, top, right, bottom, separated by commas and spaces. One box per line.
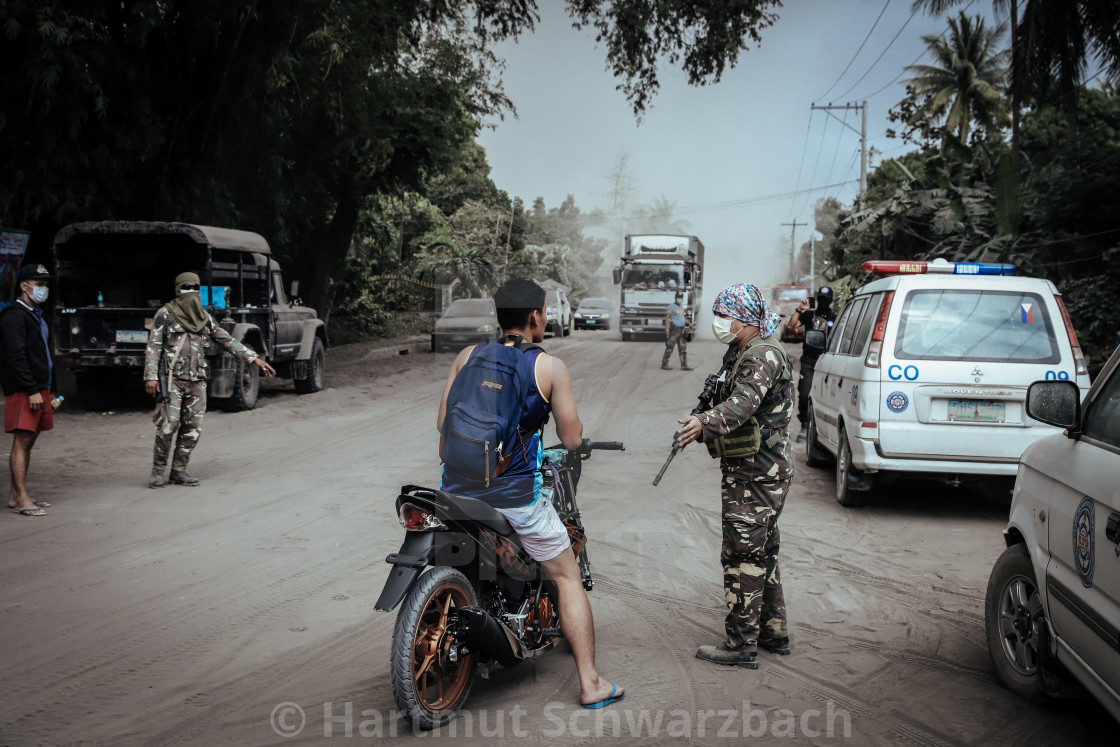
895, 290, 1061, 363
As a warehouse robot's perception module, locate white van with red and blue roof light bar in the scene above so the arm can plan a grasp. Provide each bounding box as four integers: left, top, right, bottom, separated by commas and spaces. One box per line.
805, 260, 1089, 506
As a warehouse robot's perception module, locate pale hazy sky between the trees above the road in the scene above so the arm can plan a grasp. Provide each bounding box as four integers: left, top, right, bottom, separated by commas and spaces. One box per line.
479, 0, 991, 297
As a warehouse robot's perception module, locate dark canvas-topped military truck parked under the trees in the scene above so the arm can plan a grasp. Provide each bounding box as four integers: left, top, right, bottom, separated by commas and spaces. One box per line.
52, 221, 327, 411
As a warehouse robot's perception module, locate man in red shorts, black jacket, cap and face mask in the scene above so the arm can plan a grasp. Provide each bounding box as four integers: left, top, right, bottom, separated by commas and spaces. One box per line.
0, 264, 55, 516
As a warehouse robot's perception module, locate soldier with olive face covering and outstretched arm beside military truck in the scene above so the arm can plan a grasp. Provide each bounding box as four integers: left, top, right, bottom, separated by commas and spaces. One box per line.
143, 272, 276, 487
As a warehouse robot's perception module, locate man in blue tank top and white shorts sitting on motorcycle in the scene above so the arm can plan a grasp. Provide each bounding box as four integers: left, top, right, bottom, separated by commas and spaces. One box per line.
436, 280, 624, 708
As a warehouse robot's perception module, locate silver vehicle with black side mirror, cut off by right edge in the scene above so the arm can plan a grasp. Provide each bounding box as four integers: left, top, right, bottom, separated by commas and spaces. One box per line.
984, 344, 1120, 721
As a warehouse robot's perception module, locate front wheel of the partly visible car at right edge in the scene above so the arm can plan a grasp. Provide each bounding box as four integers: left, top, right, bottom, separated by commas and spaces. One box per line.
984, 544, 1049, 703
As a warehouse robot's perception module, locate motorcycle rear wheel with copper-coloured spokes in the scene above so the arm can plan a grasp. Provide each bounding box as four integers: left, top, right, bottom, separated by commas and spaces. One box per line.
389, 566, 478, 731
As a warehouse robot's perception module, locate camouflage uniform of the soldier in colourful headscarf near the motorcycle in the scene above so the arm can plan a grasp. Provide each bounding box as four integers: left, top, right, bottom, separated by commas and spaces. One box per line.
700, 338, 794, 651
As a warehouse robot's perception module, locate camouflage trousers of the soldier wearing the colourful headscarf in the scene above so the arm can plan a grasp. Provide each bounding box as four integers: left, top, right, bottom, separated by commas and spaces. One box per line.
720, 473, 792, 651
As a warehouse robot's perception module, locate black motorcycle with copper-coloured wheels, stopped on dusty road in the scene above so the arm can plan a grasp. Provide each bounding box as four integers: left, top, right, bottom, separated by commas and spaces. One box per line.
375, 440, 625, 730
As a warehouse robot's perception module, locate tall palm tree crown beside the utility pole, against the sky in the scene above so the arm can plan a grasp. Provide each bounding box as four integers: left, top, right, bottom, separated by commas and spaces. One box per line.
906, 11, 1010, 151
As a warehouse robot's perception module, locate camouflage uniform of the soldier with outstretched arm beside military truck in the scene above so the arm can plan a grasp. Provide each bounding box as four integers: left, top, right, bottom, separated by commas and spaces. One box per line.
143, 307, 258, 471
